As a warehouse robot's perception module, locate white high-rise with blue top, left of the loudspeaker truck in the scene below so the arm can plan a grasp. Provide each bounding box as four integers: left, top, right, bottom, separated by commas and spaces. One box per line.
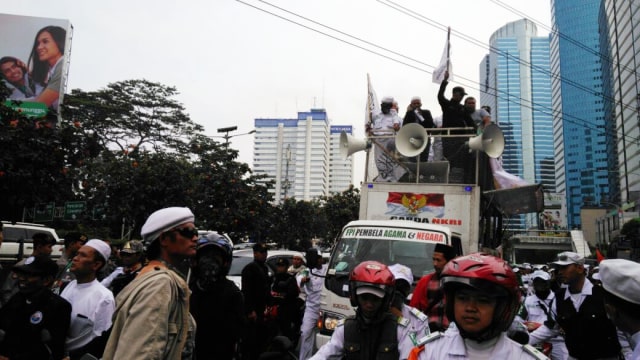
253, 109, 353, 203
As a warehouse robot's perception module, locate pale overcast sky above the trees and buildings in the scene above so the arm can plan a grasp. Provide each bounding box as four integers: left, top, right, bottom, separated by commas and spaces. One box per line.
0, 0, 550, 182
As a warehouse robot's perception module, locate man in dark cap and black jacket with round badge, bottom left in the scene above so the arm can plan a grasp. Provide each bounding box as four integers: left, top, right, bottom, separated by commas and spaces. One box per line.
0, 256, 71, 360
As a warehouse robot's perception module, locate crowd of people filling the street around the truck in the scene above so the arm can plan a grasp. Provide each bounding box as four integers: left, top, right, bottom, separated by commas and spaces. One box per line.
0, 207, 640, 360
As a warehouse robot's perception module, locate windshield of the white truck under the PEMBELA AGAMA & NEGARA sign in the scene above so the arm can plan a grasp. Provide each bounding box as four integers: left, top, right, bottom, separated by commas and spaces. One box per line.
325, 238, 435, 297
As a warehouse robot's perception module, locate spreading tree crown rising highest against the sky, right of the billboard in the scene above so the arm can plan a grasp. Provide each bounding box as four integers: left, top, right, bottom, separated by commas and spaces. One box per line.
63, 80, 204, 158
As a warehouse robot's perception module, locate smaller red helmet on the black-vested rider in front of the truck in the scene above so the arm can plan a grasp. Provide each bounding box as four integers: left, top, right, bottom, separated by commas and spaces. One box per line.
349, 261, 396, 309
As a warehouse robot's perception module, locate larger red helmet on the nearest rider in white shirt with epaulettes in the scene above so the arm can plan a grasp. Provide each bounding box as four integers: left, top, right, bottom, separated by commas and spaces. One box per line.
442, 253, 520, 341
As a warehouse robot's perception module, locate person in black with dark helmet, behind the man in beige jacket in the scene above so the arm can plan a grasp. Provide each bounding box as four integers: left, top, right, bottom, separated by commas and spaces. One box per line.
189, 233, 244, 360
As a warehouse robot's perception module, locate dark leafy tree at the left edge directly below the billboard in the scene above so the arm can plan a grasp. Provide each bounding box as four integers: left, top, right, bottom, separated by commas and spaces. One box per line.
0, 82, 100, 221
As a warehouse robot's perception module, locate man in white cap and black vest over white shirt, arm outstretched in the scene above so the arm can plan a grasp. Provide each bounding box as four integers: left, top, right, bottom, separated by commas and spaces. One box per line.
529, 251, 620, 360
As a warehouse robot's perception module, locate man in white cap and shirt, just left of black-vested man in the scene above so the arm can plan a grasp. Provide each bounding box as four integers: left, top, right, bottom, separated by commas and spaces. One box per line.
516, 270, 569, 360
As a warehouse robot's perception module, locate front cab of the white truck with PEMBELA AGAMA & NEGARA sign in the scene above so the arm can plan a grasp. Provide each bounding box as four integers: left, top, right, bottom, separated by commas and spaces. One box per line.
316, 220, 459, 348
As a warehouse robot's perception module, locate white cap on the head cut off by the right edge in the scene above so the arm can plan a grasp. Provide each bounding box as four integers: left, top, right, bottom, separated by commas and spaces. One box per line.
599, 259, 640, 305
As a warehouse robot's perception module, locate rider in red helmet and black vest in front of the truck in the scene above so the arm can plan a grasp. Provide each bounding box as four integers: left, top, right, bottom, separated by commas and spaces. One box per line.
311, 261, 413, 360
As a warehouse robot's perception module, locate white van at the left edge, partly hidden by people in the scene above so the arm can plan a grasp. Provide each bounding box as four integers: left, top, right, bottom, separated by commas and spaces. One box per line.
0, 221, 64, 264
